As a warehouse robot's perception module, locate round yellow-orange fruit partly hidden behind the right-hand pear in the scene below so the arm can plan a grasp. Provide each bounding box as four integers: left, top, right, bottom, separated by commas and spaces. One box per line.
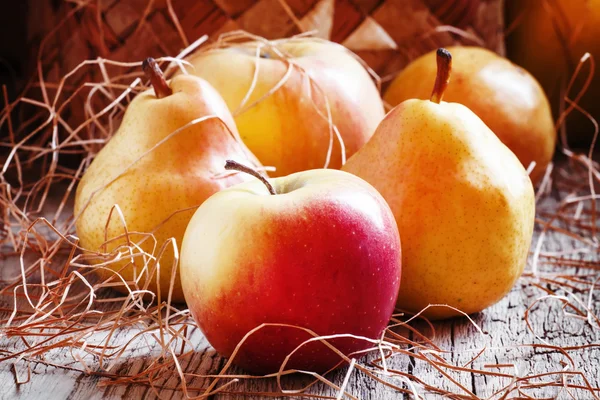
384, 47, 556, 182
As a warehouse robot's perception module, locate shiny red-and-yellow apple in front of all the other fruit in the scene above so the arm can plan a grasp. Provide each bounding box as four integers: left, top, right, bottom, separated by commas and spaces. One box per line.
181, 170, 401, 373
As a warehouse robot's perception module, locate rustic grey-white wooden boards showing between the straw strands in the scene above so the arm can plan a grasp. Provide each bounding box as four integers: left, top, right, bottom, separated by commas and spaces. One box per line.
0, 159, 600, 400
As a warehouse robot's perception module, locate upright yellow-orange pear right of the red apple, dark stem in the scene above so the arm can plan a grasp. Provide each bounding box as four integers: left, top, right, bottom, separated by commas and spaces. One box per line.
342, 49, 535, 319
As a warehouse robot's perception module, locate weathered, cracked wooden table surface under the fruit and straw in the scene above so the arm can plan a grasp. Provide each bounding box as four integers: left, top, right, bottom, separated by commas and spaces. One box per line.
0, 160, 600, 400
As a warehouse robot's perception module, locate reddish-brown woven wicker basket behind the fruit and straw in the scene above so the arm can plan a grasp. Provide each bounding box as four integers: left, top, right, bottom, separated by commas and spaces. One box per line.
8, 0, 504, 161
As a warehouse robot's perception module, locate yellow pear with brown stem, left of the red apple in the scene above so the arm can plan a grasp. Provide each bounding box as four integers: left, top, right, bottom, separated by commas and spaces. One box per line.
75, 59, 258, 302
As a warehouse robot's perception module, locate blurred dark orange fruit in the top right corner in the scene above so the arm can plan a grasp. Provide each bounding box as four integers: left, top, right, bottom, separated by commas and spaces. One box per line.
506, 0, 600, 145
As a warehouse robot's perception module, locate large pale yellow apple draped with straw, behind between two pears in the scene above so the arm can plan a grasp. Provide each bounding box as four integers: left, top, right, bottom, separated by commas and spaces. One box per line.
189, 38, 384, 176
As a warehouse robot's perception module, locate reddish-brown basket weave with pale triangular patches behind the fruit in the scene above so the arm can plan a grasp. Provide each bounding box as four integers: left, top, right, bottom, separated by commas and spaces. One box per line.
29, 0, 504, 84
